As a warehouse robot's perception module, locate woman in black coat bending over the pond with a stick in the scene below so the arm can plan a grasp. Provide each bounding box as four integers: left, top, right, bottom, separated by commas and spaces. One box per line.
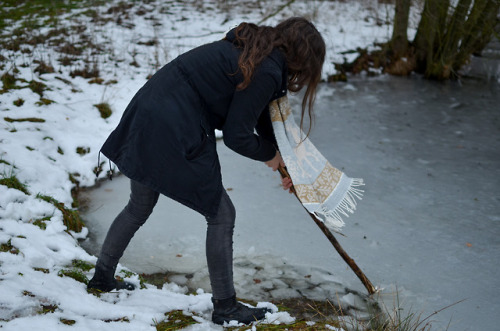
88, 17, 325, 324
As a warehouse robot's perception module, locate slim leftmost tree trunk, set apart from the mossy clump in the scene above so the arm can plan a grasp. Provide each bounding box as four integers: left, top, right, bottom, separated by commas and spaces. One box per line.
391, 0, 411, 59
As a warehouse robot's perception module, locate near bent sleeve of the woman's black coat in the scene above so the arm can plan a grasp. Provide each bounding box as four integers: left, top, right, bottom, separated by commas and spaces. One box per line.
222, 68, 282, 161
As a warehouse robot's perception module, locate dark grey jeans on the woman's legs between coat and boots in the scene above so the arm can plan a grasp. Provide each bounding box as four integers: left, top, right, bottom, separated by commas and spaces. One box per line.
97, 180, 236, 299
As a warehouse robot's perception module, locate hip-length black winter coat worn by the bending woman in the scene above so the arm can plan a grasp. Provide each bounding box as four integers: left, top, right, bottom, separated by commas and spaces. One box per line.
101, 31, 287, 217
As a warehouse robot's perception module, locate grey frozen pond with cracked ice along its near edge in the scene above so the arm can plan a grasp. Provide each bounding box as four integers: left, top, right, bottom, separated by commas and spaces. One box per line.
82, 77, 500, 330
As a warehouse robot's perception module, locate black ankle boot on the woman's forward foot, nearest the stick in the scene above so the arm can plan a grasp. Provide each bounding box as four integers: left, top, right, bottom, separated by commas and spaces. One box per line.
212, 295, 271, 324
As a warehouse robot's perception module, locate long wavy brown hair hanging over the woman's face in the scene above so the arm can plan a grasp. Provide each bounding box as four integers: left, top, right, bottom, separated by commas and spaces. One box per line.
235, 17, 326, 135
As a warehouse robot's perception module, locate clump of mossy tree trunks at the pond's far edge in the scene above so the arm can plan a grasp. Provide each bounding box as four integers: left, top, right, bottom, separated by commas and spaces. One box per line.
354, 0, 500, 79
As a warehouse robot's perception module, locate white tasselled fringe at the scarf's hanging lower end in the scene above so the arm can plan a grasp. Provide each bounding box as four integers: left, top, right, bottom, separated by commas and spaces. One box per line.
313, 178, 365, 233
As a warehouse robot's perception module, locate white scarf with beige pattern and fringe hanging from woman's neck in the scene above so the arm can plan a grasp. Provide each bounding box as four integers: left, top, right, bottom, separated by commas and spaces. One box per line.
269, 96, 364, 232
